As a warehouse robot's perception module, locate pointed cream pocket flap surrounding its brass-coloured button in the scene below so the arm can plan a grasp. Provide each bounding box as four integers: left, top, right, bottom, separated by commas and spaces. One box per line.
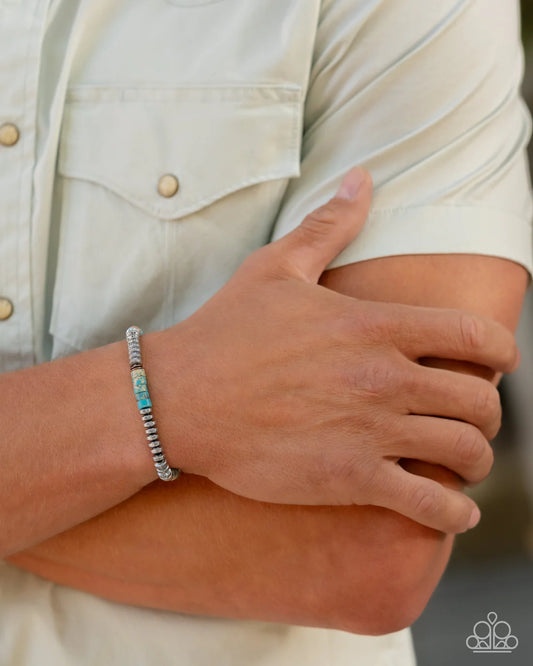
58, 85, 301, 219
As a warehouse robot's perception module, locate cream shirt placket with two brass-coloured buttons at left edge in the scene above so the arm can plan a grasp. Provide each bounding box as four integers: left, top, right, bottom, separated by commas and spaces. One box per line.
0, 0, 49, 372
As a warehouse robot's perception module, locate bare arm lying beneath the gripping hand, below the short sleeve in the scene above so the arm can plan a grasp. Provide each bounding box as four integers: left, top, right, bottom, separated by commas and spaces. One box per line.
7, 250, 527, 634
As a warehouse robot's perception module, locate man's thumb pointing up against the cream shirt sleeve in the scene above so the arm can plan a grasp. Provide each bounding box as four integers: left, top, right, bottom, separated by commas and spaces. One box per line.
270, 167, 372, 283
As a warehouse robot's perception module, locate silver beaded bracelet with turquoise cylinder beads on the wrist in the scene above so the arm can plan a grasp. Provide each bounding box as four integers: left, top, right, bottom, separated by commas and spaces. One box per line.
126, 326, 181, 481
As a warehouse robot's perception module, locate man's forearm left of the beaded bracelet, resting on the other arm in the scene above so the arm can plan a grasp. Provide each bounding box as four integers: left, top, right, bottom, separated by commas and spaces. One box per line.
0, 333, 180, 556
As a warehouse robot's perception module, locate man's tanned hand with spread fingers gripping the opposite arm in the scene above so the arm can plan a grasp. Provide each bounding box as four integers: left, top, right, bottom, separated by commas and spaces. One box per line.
163, 169, 517, 532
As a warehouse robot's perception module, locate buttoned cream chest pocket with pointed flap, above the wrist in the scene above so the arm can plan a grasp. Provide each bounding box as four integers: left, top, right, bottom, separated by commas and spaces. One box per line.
50, 86, 301, 357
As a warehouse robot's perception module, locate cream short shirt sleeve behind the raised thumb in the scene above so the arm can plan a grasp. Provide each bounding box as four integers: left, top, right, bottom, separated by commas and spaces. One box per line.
272, 0, 533, 273
